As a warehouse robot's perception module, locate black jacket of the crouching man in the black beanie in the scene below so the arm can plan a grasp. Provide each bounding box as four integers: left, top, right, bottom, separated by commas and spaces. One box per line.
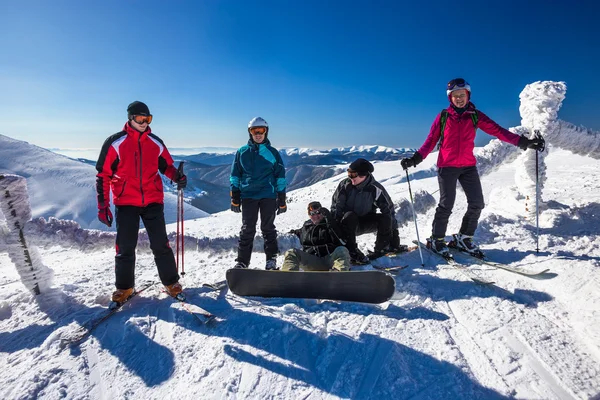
331, 175, 394, 222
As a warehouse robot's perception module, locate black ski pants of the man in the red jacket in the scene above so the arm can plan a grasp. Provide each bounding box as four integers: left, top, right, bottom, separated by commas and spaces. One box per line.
115, 203, 179, 289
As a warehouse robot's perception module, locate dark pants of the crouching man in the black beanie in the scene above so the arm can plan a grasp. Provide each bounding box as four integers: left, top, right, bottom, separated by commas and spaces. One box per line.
340, 211, 400, 253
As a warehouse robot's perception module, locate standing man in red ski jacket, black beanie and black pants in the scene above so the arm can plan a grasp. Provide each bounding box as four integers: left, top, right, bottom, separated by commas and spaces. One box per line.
96, 101, 187, 305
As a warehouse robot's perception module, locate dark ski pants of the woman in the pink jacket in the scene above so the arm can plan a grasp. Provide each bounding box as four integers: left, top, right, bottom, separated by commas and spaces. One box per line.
432, 167, 485, 238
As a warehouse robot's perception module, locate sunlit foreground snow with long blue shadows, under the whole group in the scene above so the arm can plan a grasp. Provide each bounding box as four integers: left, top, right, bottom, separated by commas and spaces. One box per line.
0, 142, 600, 400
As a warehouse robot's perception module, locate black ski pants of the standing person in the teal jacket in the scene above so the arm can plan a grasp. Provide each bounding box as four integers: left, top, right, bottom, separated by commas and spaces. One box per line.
235, 199, 279, 266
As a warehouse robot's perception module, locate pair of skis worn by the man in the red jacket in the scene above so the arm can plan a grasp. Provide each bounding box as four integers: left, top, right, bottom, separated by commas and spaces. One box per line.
62, 282, 215, 346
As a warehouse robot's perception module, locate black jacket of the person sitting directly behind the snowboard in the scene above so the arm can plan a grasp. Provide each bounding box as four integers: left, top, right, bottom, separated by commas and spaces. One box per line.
292, 217, 345, 257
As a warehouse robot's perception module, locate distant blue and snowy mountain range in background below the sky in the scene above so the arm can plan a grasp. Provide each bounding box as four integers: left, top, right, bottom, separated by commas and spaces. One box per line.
0, 135, 414, 225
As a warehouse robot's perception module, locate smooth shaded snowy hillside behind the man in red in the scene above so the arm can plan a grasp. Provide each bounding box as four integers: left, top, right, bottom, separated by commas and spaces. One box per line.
0, 135, 208, 230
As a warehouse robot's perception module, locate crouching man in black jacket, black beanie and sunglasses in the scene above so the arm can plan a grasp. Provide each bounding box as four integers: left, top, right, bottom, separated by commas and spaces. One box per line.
331, 158, 407, 263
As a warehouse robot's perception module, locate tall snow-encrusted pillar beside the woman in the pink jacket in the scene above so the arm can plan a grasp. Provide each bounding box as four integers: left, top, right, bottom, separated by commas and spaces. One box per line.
515, 81, 567, 218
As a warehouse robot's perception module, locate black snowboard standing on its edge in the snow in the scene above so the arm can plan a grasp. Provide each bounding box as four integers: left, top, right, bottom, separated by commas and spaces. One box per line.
226, 268, 396, 303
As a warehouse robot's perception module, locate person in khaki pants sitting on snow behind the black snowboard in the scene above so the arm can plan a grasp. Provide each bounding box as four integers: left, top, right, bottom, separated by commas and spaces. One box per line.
282, 201, 350, 271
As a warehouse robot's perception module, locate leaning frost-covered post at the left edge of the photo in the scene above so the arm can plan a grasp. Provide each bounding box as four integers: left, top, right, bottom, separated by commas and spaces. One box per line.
0, 175, 52, 294
